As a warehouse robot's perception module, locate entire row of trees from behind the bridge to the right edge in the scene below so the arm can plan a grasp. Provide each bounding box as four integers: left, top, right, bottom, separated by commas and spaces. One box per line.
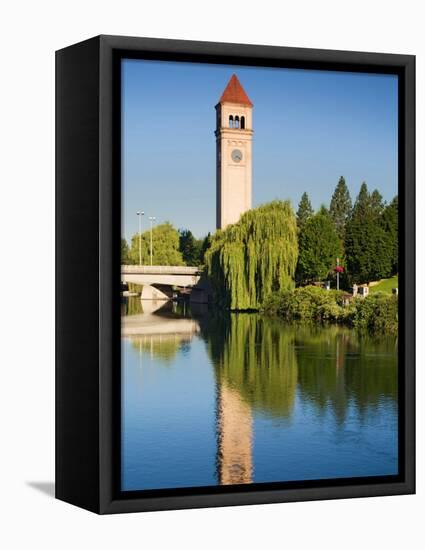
121, 176, 398, 294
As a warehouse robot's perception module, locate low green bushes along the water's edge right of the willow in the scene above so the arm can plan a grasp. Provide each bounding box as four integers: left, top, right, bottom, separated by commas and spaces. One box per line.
261, 286, 398, 334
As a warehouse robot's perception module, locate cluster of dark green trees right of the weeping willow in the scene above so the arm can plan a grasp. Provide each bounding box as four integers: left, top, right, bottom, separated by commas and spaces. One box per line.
295, 176, 398, 286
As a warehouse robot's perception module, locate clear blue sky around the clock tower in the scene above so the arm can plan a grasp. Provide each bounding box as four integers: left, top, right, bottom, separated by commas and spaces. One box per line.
122, 60, 398, 240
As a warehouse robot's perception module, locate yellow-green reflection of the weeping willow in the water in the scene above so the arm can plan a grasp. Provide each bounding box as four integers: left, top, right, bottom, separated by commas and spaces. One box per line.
201, 314, 297, 417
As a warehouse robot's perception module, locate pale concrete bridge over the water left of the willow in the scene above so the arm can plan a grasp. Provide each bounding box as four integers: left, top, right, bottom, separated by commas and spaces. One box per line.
121, 265, 207, 303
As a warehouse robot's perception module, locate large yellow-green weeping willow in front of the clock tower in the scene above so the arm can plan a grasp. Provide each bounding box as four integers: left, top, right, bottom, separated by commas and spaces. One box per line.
205, 201, 298, 310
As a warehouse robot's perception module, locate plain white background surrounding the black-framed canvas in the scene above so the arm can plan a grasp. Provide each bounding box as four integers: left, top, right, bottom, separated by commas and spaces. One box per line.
0, 0, 425, 550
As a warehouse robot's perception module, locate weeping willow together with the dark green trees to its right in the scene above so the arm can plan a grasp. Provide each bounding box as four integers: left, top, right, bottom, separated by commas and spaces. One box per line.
200, 177, 398, 312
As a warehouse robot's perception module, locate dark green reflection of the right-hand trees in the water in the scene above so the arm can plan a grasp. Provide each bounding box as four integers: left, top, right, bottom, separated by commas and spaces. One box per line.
295, 327, 398, 423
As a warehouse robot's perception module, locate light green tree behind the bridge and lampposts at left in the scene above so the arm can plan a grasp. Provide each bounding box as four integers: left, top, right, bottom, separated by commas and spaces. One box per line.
129, 222, 184, 265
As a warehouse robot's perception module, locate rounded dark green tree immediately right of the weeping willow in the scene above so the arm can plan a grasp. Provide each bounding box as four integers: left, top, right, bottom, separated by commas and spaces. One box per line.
297, 206, 342, 283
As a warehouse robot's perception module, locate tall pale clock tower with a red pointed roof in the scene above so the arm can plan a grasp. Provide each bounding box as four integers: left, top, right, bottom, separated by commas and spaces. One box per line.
215, 74, 253, 229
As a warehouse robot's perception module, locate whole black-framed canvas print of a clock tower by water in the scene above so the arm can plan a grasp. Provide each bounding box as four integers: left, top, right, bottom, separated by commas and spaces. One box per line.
56, 36, 415, 513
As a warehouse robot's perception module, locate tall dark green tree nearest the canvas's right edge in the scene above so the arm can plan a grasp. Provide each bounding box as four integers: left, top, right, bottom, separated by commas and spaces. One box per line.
345, 183, 392, 283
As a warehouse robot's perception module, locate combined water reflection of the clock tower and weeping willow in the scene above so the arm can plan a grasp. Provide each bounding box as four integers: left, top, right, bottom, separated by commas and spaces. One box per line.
205, 314, 297, 485
